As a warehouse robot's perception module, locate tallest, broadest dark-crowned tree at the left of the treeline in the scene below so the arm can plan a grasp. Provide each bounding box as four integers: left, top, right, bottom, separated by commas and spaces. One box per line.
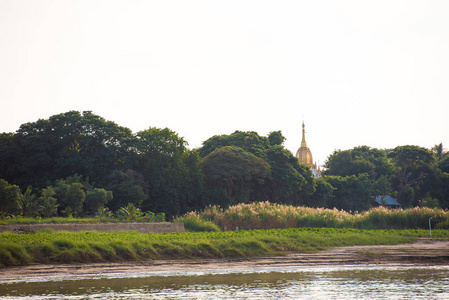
10, 111, 134, 188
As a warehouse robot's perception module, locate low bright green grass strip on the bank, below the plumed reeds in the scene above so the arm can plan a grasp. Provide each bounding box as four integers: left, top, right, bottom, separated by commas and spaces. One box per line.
0, 228, 449, 266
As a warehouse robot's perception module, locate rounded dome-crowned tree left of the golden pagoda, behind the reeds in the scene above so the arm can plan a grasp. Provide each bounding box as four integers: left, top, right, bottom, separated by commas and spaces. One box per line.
202, 146, 270, 205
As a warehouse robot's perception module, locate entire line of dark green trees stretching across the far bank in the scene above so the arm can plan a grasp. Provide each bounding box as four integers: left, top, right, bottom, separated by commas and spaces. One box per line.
0, 111, 449, 218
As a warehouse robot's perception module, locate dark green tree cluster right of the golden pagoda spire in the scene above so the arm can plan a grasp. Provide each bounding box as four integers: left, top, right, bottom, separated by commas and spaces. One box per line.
324, 144, 449, 210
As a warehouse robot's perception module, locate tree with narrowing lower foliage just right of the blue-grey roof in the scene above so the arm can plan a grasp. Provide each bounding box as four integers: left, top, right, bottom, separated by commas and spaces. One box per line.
388, 146, 435, 204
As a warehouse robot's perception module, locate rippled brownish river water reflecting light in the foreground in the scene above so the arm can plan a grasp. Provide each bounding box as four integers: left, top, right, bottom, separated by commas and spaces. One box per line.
0, 266, 449, 299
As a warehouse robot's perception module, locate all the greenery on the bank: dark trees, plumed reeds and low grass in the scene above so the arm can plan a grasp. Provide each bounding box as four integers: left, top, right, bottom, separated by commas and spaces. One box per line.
0, 111, 449, 266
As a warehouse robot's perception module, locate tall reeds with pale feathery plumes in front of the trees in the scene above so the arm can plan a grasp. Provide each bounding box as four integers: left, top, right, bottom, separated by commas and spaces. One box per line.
183, 202, 449, 230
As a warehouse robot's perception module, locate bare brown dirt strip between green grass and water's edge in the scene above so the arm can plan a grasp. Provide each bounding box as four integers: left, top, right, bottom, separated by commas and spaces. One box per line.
0, 239, 449, 281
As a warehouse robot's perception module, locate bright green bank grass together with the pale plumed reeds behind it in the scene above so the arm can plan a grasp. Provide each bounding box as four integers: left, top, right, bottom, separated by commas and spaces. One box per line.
0, 202, 449, 266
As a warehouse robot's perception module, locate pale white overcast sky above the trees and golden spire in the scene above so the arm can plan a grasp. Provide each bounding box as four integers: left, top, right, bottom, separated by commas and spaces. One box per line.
0, 0, 449, 164
